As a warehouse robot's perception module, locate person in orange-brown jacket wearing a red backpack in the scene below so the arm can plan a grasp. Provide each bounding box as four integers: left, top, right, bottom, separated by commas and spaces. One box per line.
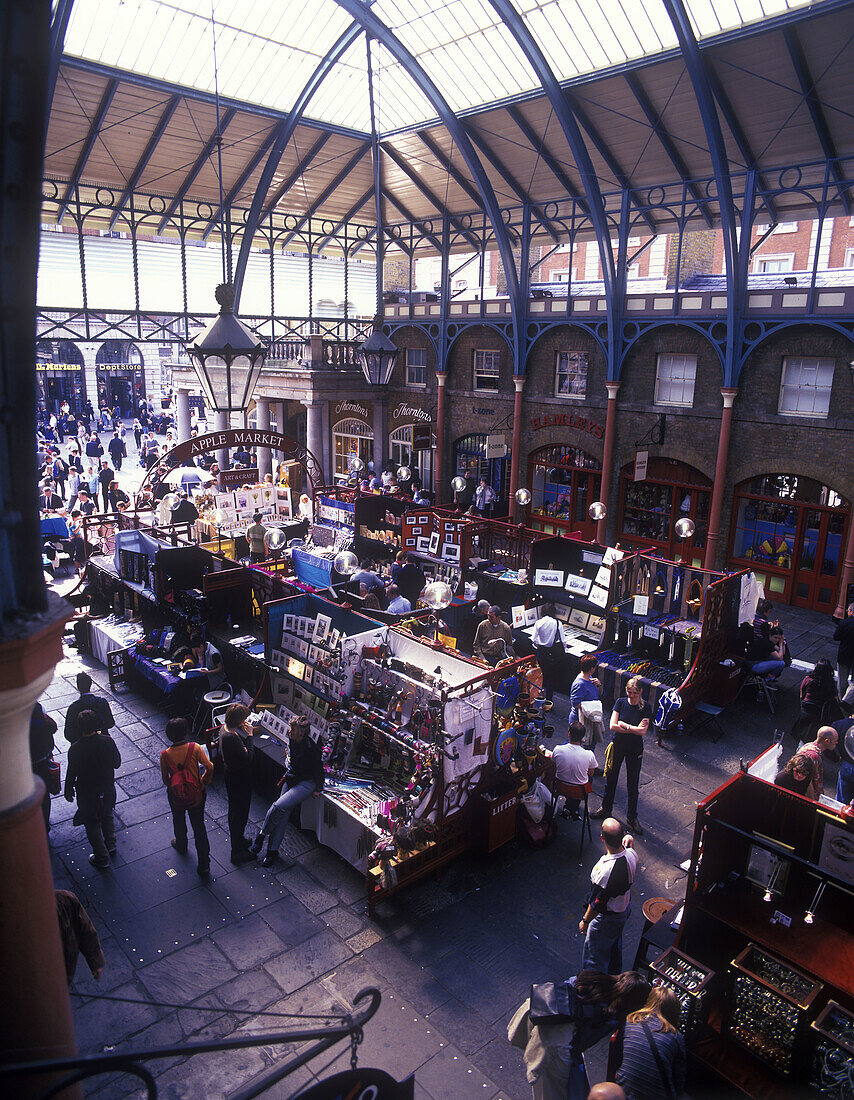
161, 718, 214, 879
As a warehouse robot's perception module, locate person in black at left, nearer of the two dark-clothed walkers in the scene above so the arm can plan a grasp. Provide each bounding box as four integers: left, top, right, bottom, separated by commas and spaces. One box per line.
65, 711, 121, 870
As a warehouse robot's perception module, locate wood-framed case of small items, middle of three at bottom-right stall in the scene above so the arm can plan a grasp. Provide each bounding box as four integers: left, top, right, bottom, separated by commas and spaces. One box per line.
726, 944, 823, 1075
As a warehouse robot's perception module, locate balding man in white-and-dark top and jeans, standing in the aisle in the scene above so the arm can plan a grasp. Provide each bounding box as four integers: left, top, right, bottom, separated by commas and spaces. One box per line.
578, 817, 637, 974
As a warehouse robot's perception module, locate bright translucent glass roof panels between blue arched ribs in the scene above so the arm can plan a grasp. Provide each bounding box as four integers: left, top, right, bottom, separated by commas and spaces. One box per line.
58, 0, 819, 133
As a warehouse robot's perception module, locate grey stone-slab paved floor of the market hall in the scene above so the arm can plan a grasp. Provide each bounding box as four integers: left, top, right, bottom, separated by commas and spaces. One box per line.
43, 608, 835, 1100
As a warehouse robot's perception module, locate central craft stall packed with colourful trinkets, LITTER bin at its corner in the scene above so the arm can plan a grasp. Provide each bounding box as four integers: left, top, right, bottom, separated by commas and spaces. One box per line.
255, 595, 530, 911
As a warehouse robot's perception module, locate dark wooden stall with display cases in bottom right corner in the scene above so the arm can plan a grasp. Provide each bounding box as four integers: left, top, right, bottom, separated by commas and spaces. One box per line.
673, 765, 854, 1100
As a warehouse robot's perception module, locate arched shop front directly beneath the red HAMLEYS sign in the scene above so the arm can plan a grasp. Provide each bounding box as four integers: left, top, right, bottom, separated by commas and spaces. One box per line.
527, 444, 602, 540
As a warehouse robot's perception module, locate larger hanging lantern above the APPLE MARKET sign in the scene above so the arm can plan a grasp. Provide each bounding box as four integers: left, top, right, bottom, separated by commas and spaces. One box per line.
187, 283, 267, 413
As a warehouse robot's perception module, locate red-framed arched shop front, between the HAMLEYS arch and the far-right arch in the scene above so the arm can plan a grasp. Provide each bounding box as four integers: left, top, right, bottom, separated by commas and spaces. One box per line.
617, 458, 712, 567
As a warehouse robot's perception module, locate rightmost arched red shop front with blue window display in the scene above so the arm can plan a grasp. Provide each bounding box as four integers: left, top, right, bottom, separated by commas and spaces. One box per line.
730, 474, 851, 614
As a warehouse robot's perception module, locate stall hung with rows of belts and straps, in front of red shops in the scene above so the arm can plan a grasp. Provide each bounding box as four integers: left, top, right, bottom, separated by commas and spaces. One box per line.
596, 553, 746, 725
